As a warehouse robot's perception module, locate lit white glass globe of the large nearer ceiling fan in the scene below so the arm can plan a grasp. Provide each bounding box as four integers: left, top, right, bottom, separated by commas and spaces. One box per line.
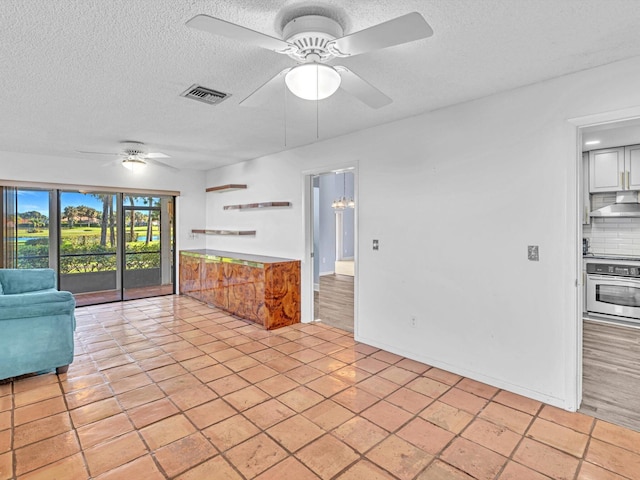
284, 62, 342, 100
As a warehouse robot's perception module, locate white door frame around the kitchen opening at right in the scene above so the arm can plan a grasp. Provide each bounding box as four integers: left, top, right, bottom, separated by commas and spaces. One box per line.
566, 106, 640, 411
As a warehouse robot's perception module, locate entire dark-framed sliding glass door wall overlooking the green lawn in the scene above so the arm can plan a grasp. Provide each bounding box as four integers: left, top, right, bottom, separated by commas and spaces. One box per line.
0, 186, 175, 306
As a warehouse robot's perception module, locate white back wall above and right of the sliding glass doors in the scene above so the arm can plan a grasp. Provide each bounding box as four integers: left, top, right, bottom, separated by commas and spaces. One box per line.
0, 152, 206, 284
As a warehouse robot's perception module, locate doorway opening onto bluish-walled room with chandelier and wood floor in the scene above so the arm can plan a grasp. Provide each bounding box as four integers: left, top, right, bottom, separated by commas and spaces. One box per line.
312, 168, 356, 332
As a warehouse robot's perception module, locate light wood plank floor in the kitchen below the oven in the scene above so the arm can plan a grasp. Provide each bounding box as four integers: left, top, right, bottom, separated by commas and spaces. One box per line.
579, 320, 640, 431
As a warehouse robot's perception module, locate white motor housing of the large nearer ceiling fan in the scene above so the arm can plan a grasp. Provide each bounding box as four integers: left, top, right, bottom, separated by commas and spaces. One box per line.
282, 15, 344, 62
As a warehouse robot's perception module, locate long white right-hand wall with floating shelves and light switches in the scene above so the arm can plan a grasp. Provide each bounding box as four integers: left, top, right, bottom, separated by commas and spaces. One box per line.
207, 55, 640, 409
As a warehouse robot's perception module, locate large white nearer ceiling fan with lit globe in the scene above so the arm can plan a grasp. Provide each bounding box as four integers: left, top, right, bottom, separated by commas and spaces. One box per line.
186, 12, 433, 108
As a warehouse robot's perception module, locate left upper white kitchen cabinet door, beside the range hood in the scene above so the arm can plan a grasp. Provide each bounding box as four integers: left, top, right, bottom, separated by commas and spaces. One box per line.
589, 147, 627, 193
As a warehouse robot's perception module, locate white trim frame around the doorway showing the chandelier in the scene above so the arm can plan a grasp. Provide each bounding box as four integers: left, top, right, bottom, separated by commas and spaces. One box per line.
301, 160, 360, 337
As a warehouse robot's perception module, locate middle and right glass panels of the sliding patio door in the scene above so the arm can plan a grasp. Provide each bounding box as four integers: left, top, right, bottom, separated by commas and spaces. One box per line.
59, 191, 174, 305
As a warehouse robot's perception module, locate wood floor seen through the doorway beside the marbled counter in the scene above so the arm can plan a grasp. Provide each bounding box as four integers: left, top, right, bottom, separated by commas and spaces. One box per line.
314, 275, 353, 332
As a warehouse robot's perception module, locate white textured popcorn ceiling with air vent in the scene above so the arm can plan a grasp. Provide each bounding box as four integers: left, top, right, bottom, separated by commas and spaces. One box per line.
0, 0, 640, 169
